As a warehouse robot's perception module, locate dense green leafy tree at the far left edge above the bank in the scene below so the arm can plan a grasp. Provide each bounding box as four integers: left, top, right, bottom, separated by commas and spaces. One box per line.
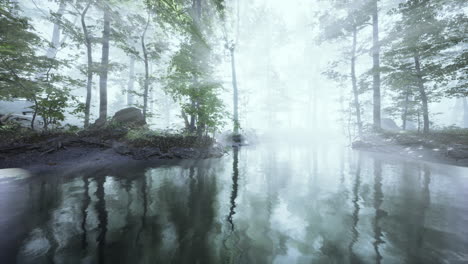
0, 2, 78, 129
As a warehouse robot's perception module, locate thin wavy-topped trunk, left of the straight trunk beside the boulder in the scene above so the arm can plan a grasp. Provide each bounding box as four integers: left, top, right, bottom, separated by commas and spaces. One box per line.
81, 1, 93, 128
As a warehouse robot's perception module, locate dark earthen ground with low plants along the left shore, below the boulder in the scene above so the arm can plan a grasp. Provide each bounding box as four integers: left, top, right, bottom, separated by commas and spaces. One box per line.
0, 128, 225, 170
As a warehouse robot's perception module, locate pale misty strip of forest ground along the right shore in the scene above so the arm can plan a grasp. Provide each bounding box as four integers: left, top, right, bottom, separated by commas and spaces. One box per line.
352, 129, 468, 167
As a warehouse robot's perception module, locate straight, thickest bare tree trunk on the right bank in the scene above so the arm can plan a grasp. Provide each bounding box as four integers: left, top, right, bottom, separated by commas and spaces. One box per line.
372, 0, 381, 130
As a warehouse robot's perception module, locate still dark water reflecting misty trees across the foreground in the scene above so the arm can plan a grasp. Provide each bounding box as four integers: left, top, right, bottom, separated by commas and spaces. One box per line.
0, 142, 468, 264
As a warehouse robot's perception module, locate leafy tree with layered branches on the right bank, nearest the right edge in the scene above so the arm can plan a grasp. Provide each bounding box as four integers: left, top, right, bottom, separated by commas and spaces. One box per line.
386, 0, 460, 133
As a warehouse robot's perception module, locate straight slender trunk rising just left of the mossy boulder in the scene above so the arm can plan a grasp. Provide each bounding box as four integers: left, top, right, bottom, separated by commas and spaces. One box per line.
99, 6, 111, 124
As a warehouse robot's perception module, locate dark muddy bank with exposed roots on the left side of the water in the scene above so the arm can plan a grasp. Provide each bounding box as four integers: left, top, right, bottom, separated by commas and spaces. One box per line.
0, 132, 225, 170
